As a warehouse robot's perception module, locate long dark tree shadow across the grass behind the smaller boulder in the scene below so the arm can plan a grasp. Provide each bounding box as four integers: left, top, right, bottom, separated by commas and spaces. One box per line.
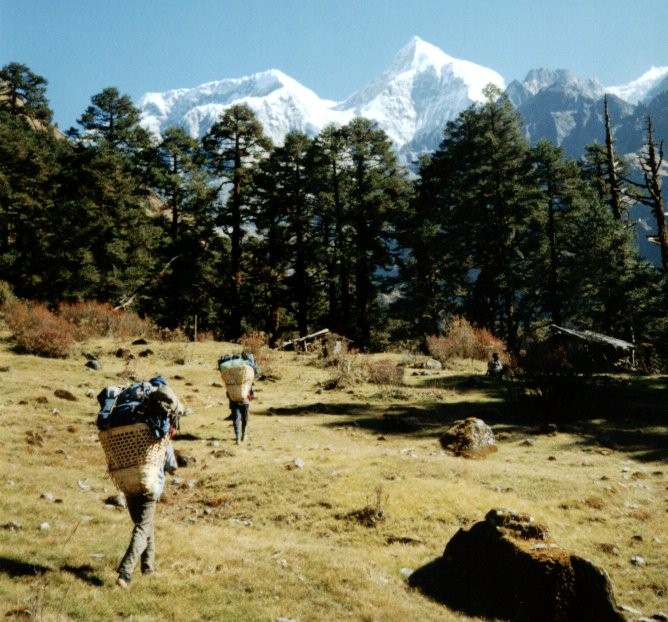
261, 375, 668, 462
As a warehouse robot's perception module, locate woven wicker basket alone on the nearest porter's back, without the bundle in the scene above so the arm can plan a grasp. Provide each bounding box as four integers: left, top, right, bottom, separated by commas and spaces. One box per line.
100, 423, 169, 495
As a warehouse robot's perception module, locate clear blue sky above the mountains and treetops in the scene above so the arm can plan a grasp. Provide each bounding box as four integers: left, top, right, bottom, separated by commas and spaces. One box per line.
0, 0, 668, 129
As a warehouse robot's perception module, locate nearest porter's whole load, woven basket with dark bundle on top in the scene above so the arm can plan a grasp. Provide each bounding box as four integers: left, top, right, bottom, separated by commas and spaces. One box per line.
97, 377, 180, 496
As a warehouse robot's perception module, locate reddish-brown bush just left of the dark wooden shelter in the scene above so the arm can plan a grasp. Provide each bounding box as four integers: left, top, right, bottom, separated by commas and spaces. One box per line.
427, 316, 507, 364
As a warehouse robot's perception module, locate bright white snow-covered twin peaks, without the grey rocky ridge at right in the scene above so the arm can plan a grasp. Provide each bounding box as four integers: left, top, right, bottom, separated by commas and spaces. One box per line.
138, 37, 505, 161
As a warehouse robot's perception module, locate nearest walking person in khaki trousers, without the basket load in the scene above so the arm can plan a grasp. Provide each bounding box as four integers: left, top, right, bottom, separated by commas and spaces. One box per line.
116, 376, 184, 588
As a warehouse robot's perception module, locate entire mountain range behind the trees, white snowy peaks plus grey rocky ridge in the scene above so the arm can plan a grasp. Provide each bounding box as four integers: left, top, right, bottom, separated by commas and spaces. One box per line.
138, 37, 668, 162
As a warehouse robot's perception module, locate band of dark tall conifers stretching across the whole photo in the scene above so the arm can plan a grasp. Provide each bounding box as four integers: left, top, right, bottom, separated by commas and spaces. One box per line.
0, 63, 668, 360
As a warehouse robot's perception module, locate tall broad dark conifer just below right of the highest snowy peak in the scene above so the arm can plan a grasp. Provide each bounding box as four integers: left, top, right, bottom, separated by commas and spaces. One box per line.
410, 86, 543, 350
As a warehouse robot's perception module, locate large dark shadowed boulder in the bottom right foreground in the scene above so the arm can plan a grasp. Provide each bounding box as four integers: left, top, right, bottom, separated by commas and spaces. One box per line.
410, 510, 626, 622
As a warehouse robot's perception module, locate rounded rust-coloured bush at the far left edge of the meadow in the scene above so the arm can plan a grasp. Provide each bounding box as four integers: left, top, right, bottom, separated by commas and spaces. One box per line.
4, 302, 76, 358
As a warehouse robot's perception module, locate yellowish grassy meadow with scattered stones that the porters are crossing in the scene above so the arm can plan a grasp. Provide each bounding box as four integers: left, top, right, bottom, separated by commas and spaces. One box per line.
0, 333, 668, 622
